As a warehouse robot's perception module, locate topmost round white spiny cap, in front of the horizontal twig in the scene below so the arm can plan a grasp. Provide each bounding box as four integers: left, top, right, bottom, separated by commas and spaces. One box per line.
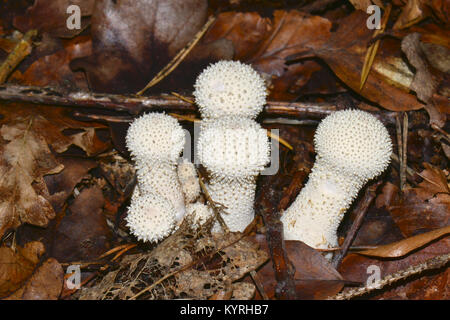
194, 61, 267, 119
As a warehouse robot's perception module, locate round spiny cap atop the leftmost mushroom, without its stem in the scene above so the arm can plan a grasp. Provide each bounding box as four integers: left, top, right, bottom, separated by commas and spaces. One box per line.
126, 113, 185, 162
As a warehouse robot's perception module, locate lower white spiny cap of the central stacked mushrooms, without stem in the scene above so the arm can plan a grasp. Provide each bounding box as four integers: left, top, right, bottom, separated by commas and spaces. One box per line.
197, 117, 270, 178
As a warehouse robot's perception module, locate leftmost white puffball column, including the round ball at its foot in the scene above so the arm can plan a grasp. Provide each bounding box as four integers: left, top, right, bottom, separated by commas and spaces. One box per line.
126, 113, 185, 241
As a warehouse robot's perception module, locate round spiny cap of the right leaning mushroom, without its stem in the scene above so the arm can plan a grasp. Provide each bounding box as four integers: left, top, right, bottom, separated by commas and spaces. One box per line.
314, 110, 392, 181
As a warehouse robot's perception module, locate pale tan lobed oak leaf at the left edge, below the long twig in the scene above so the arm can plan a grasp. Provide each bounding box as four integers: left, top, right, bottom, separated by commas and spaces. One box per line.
0, 105, 108, 236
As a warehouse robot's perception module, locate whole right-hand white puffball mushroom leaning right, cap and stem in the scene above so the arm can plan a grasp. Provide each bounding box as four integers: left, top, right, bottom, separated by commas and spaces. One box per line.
281, 110, 392, 249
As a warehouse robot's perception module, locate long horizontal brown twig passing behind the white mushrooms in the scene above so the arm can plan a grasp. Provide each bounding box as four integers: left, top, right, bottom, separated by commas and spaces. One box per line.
0, 85, 396, 126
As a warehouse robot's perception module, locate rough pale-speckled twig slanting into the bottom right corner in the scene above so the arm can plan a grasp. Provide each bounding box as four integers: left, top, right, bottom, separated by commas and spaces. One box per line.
328, 253, 450, 300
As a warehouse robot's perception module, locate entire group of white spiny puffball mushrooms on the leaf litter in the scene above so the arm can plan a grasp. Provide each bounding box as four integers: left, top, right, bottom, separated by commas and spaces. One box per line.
126, 61, 392, 255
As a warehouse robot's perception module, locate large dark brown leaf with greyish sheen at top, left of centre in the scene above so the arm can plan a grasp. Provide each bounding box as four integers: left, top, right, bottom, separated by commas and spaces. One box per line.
71, 0, 207, 93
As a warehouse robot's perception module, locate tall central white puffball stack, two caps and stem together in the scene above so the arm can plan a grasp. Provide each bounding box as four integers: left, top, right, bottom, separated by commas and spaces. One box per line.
194, 61, 270, 231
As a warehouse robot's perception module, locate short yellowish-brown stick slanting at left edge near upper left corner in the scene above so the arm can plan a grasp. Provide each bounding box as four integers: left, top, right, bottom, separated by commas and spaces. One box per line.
0, 30, 37, 83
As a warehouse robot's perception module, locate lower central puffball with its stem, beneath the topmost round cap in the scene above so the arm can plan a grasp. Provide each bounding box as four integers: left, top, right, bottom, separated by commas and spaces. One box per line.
197, 117, 270, 231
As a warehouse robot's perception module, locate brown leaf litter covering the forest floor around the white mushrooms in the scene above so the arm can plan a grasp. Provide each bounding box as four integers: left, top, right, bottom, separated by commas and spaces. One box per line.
0, 0, 450, 299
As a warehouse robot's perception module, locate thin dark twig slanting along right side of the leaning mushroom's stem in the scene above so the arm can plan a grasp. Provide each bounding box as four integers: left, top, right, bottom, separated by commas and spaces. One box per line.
332, 180, 383, 269
